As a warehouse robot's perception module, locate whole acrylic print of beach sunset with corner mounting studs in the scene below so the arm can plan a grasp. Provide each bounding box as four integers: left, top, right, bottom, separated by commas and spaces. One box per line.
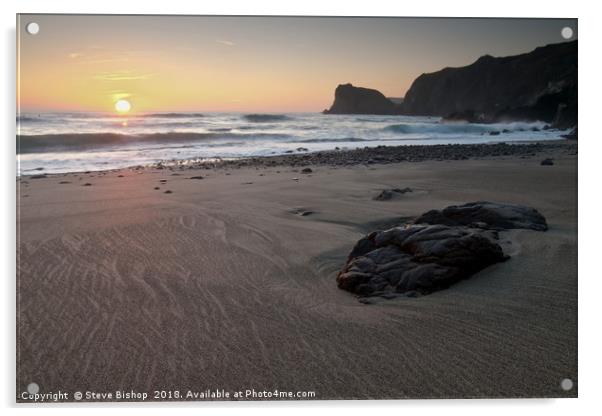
16, 14, 578, 403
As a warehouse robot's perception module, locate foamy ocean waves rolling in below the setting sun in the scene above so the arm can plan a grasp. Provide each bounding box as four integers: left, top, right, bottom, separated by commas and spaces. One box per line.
17, 113, 568, 175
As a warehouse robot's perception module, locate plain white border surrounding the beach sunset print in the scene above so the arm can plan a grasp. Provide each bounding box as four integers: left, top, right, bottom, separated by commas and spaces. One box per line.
0, 0, 602, 416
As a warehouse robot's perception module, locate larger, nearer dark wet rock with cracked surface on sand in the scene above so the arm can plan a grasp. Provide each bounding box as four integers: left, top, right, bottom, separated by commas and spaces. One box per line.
337, 225, 507, 296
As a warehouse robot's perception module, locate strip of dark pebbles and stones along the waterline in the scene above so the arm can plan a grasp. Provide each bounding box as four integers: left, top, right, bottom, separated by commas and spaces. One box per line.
162, 140, 577, 169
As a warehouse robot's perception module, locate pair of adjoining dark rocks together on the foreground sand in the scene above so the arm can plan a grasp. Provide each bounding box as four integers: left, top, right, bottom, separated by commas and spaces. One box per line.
337, 202, 547, 298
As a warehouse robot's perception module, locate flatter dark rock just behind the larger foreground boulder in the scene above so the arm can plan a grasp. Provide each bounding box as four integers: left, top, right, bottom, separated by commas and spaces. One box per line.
414, 201, 548, 231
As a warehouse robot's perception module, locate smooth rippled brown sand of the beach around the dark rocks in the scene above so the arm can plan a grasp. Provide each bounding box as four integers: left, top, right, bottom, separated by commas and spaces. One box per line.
17, 142, 577, 399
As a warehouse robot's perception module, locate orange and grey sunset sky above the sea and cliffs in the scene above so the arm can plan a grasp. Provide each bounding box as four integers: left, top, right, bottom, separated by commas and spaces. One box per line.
17, 15, 577, 112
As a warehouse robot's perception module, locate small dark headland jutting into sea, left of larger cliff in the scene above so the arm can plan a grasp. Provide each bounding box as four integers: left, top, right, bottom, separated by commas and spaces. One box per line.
324, 84, 399, 114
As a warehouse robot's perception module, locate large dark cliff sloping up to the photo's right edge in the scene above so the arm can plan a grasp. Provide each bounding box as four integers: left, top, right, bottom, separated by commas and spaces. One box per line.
403, 41, 577, 128
